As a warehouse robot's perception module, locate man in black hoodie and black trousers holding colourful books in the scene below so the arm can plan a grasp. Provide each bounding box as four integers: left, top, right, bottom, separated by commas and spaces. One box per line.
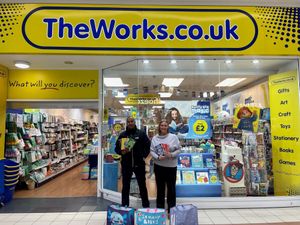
115, 117, 151, 208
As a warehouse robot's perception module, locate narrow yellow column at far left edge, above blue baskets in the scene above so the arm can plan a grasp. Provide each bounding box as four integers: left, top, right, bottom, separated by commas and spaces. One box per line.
0, 65, 8, 159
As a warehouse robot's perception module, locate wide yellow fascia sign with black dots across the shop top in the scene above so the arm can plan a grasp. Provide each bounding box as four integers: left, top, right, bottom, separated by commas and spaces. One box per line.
0, 3, 300, 55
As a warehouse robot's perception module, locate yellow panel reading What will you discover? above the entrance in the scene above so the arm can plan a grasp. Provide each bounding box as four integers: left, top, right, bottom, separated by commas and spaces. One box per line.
7, 70, 98, 99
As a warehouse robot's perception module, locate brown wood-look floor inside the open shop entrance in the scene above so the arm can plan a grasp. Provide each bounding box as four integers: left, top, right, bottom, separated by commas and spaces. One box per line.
14, 163, 97, 198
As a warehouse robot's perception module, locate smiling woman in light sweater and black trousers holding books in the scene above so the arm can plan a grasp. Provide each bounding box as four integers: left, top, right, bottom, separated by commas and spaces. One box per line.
150, 120, 181, 213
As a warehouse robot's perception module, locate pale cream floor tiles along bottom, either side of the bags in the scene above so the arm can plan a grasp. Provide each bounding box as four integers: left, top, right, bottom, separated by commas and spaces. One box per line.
0, 207, 300, 225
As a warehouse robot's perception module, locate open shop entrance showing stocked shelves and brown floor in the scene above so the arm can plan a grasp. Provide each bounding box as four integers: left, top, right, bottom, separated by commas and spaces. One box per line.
5, 101, 99, 198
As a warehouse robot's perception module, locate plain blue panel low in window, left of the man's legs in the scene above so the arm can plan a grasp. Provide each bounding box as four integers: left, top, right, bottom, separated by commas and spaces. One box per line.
103, 162, 119, 191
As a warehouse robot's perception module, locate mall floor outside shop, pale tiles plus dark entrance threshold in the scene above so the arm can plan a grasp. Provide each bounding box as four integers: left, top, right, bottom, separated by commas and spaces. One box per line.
0, 197, 300, 225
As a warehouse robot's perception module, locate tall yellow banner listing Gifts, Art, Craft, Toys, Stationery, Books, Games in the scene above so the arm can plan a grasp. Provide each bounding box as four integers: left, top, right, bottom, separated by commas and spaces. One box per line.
269, 71, 300, 196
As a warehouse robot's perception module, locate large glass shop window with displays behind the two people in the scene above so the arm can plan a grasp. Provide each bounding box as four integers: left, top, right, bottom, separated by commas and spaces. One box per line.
101, 58, 300, 198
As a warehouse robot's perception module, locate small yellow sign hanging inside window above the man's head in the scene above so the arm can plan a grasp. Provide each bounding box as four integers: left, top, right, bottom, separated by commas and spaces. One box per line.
125, 94, 161, 105
